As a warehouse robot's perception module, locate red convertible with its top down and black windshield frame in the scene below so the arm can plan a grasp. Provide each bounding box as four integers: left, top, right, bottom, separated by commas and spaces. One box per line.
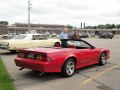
15, 39, 110, 77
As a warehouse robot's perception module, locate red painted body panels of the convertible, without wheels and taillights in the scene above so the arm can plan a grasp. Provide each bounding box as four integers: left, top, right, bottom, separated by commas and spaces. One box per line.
15, 48, 109, 72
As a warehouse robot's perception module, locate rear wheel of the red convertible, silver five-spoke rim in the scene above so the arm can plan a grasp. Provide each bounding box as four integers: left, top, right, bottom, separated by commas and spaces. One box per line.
62, 58, 75, 77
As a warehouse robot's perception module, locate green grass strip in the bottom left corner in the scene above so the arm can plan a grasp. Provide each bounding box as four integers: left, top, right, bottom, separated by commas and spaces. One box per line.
0, 58, 15, 90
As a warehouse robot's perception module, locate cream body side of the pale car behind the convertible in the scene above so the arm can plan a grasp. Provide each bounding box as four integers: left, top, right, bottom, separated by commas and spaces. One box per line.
0, 39, 59, 50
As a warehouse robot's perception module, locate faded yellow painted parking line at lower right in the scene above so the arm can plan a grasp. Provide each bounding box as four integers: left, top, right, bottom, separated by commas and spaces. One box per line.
71, 63, 120, 90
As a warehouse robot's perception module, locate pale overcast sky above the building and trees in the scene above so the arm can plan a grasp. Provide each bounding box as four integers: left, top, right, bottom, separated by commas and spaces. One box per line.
0, 0, 120, 27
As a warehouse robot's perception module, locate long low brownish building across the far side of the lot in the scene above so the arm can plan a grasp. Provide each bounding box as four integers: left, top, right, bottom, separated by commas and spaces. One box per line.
8, 23, 120, 34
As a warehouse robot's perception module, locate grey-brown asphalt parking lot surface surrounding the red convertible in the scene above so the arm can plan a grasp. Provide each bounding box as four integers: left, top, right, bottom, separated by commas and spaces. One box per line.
0, 38, 120, 90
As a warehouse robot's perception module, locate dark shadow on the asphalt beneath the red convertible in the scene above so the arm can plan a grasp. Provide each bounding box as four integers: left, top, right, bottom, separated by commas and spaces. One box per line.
12, 63, 112, 86
